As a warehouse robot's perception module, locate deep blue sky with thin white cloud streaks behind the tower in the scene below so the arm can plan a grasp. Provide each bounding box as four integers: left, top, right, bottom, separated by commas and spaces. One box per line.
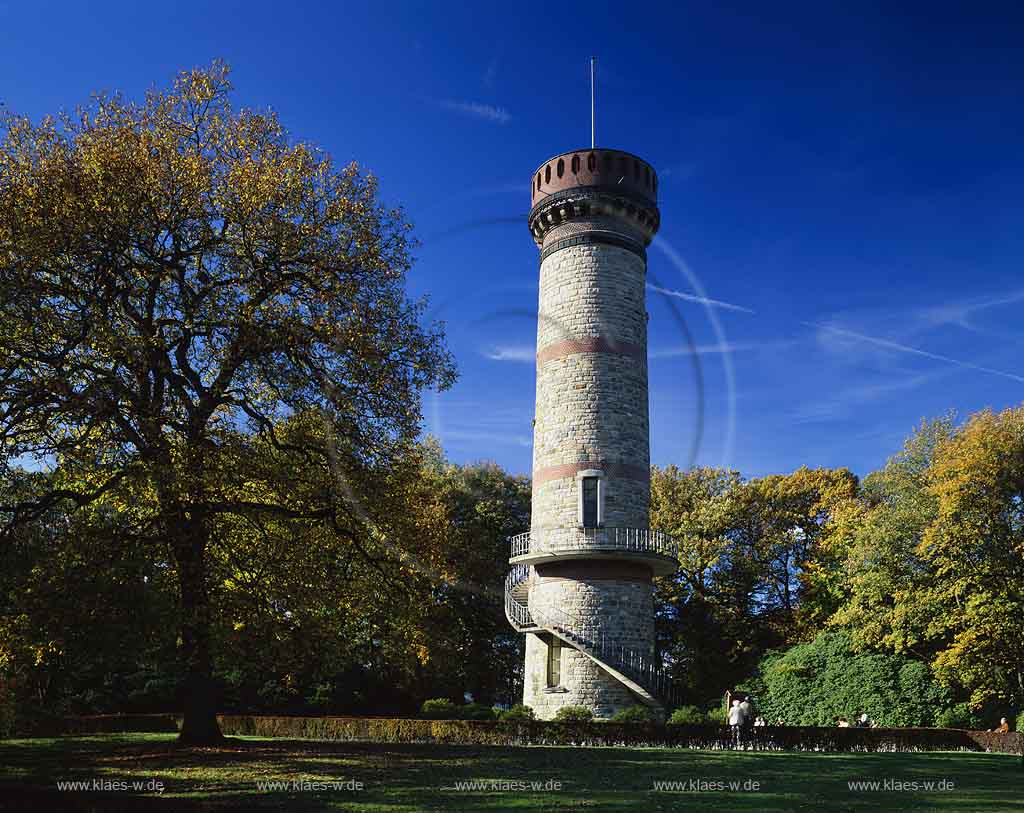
0, 0, 1024, 476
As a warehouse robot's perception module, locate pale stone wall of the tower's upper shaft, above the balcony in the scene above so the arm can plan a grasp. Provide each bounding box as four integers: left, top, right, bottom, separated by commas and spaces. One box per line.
531, 245, 650, 529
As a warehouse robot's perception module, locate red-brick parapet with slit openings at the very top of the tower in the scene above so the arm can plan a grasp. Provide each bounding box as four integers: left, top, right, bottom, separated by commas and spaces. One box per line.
529, 147, 657, 207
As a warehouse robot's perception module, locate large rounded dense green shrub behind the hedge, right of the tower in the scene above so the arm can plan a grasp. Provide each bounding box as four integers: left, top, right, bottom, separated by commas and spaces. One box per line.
758, 633, 950, 726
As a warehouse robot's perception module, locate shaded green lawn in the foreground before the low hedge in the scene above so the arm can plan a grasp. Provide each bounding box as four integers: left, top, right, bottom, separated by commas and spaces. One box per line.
0, 734, 1024, 813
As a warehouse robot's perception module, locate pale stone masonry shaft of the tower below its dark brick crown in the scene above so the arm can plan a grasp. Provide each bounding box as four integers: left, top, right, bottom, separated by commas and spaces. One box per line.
523, 177, 654, 720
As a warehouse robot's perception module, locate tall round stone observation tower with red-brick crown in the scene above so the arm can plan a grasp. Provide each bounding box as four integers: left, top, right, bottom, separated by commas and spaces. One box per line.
505, 149, 677, 719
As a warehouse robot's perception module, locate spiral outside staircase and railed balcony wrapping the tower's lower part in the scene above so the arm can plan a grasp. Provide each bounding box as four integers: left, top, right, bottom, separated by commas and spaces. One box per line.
505, 528, 679, 710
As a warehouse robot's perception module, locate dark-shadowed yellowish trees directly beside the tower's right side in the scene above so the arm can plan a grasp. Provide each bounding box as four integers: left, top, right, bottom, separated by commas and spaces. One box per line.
651, 466, 860, 704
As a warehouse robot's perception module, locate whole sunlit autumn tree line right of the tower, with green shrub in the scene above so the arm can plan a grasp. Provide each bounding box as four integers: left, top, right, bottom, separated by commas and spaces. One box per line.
652, 408, 1024, 725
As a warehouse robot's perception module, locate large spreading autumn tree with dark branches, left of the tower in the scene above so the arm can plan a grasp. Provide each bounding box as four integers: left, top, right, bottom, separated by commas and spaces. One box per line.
0, 63, 454, 742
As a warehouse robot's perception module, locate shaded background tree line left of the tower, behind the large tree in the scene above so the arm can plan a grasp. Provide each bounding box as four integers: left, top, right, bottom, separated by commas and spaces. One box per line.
0, 441, 529, 716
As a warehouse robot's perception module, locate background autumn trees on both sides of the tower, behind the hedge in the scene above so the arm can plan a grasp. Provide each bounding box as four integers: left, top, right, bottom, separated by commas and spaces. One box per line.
0, 408, 1024, 725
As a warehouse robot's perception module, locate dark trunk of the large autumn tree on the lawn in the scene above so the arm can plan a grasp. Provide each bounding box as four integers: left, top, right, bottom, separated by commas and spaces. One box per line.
174, 518, 223, 744
